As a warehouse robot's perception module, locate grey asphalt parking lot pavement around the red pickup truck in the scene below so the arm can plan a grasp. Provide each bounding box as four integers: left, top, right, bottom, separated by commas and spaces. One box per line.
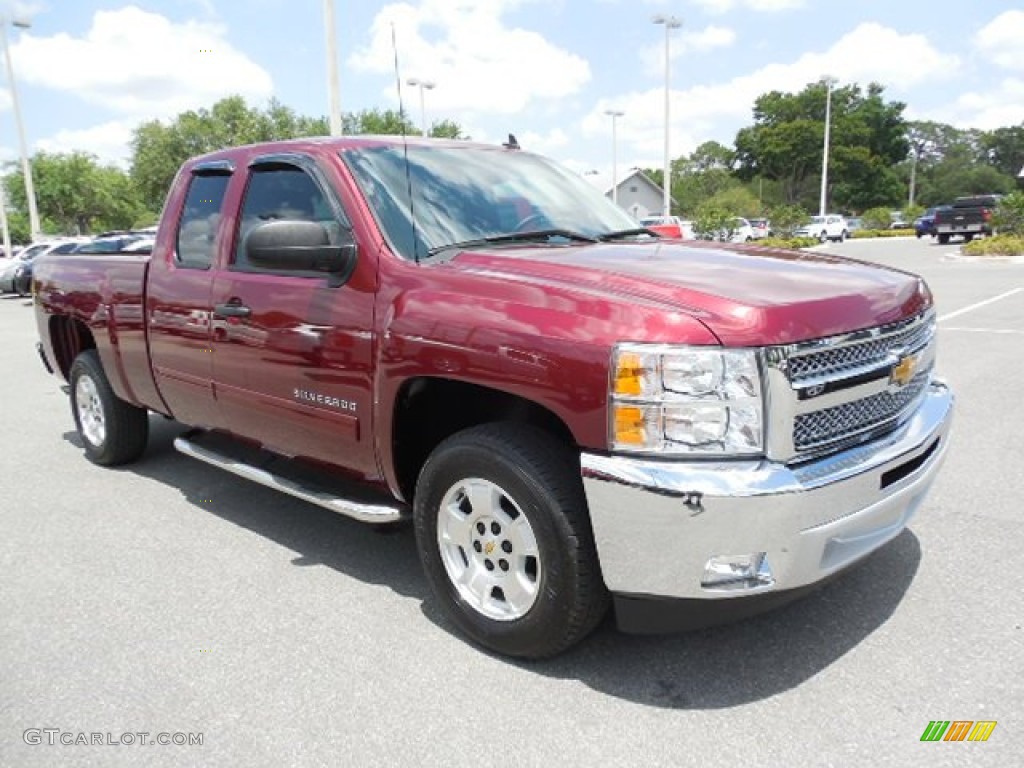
0, 240, 1024, 768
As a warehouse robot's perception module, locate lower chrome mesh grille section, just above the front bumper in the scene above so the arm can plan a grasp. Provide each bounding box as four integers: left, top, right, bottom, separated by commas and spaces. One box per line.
793, 370, 931, 452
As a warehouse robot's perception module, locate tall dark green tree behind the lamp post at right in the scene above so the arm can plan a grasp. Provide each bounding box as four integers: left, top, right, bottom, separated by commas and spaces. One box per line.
736, 83, 908, 208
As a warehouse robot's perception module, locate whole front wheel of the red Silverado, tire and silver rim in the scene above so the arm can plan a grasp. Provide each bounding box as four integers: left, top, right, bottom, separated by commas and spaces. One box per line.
414, 423, 608, 658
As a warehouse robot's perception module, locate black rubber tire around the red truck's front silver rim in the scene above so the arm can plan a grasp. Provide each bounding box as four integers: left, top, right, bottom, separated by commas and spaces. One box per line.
414, 423, 608, 658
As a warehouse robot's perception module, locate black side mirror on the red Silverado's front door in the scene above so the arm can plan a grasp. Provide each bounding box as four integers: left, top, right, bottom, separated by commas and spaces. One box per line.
246, 219, 357, 286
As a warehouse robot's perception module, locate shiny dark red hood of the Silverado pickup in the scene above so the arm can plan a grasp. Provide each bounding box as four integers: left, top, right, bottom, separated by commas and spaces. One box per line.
443, 241, 931, 346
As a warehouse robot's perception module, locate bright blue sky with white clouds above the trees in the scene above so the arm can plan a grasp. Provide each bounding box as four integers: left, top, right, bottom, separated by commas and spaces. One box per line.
0, 0, 1024, 179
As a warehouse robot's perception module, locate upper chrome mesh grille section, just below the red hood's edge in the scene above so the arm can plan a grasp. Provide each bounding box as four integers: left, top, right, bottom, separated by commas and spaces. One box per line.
787, 315, 935, 384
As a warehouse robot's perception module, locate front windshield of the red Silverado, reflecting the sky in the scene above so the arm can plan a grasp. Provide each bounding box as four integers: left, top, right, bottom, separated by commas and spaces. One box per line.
341, 145, 637, 259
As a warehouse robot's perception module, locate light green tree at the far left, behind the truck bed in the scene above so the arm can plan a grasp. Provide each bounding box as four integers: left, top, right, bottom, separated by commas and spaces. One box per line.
5, 152, 143, 234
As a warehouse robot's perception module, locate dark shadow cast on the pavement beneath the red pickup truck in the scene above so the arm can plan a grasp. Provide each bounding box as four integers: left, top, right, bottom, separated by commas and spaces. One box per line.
63, 416, 921, 710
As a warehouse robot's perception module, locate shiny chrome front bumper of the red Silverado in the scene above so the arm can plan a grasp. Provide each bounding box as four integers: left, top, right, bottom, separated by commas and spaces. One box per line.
582, 382, 953, 600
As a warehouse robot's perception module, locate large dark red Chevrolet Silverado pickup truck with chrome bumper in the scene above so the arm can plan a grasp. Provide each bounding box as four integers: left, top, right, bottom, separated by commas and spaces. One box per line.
33, 137, 953, 657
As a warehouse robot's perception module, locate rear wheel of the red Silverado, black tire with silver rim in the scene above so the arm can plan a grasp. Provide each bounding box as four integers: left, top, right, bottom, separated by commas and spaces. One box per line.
68, 349, 150, 467
